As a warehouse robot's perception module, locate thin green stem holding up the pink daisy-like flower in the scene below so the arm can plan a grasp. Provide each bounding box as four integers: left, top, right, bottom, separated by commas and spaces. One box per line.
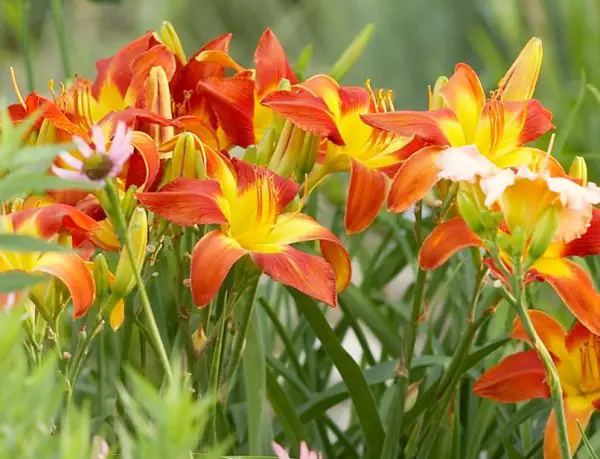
105, 180, 173, 383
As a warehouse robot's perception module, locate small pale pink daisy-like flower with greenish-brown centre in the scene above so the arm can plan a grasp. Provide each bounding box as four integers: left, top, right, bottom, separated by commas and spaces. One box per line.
52, 122, 133, 186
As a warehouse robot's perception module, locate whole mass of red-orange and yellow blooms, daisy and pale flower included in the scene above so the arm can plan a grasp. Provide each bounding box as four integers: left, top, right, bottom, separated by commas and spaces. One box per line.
0, 24, 600, 457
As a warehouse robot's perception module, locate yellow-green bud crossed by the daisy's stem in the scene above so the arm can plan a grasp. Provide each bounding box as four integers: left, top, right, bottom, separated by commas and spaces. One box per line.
112, 207, 148, 298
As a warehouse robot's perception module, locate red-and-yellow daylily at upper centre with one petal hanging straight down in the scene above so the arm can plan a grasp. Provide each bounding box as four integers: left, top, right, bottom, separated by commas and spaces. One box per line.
263, 75, 422, 233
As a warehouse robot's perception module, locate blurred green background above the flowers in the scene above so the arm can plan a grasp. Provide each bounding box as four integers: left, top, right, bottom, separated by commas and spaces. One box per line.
0, 0, 600, 169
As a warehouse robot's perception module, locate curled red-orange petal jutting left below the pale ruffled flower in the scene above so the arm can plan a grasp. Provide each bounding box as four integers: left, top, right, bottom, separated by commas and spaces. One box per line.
419, 218, 482, 271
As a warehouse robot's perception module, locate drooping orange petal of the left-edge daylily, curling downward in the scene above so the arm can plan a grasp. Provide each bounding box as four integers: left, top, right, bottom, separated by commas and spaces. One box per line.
33, 252, 96, 319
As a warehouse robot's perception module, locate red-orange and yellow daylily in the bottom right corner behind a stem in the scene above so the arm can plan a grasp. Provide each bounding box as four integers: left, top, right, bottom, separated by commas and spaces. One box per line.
473, 311, 600, 459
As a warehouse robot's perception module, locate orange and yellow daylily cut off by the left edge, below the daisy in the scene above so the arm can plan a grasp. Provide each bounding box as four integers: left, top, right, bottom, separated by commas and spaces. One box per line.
0, 205, 96, 319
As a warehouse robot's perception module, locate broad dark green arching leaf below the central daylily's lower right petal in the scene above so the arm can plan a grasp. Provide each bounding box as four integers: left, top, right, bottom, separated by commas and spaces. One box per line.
288, 288, 385, 458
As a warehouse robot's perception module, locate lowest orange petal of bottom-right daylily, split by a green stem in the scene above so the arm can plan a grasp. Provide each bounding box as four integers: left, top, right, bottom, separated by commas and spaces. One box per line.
544, 397, 594, 459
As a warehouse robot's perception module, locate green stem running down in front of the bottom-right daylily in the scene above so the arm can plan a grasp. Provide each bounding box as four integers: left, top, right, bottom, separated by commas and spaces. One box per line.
512, 257, 572, 459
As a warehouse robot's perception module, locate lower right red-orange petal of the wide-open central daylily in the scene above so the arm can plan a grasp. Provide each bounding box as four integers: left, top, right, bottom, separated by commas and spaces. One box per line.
251, 246, 337, 306
